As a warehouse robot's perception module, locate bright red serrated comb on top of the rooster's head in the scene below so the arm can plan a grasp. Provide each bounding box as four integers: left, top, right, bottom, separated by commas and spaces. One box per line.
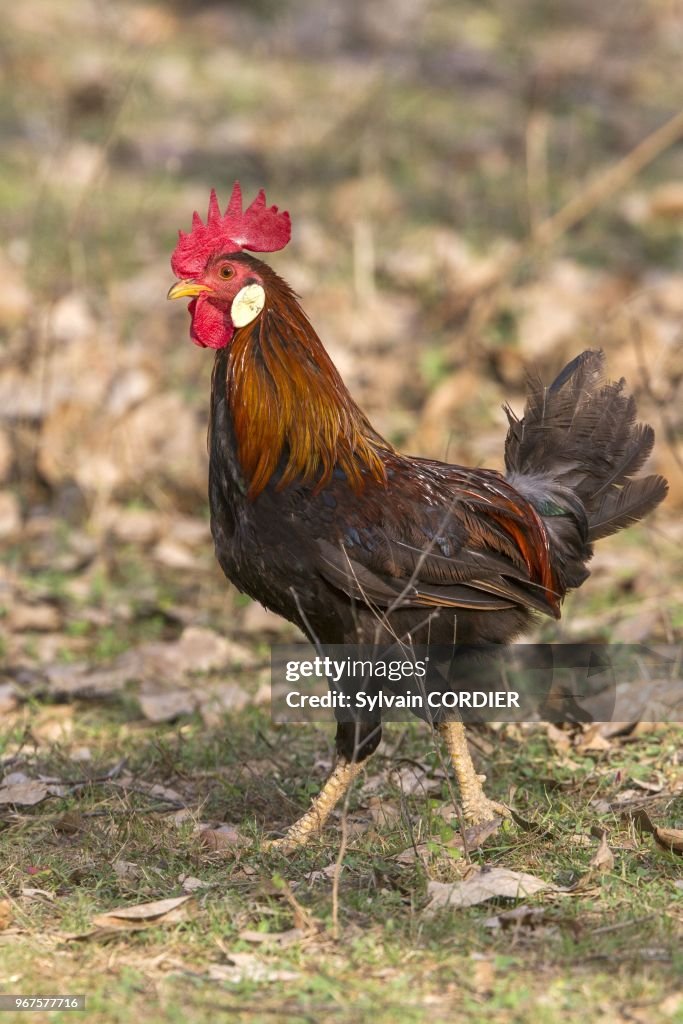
171, 181, 292, 278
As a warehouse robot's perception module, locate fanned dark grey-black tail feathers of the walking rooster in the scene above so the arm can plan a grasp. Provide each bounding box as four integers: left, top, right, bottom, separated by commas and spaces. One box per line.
505, 350, 668, 587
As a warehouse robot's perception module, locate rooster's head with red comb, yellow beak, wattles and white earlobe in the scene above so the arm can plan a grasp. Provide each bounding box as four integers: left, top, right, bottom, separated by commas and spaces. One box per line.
168, 188, 292, 348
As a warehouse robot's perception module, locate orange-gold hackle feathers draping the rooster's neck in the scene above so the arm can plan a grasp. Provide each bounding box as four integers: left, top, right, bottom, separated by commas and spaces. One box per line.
226, 256, 393, 500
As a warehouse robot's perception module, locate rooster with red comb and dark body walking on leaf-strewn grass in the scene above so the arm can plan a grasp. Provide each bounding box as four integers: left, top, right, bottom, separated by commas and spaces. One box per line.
168, 183, 667, 850
